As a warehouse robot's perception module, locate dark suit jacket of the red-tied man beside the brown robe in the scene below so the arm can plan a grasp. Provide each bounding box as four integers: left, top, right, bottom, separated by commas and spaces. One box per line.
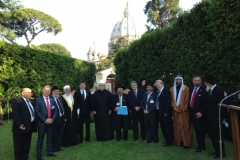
189, 86, 207, 118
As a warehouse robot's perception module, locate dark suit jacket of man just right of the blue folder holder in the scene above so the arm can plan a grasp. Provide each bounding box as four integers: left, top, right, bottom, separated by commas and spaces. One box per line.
128, 88, 145, 110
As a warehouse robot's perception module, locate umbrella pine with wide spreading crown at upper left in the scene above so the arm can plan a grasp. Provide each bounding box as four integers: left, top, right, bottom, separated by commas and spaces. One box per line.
0, 5, 62, 47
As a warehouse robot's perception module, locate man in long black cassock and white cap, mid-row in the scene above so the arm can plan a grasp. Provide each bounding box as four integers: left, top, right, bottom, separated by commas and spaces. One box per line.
92, 80, 113, 141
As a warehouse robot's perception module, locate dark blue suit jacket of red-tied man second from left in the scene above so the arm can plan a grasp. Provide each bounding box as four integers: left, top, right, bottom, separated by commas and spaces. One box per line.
34, 96, 58, 127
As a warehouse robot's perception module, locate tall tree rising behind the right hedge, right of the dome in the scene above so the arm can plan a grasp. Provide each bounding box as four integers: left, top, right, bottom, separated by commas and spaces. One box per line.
144, 0, 180, 31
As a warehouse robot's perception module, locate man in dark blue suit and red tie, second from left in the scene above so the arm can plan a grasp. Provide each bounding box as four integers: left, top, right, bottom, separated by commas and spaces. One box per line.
34, 85, 58, 160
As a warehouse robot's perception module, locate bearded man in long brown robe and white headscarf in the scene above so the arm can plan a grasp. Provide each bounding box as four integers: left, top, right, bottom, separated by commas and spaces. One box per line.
170, 75, 192, 148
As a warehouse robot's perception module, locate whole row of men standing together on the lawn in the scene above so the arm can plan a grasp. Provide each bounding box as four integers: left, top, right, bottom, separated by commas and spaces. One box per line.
12, 75, 229, 160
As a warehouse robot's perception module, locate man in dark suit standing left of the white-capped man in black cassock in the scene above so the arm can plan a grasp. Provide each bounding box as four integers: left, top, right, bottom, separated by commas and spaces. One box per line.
74, 82, 92, 143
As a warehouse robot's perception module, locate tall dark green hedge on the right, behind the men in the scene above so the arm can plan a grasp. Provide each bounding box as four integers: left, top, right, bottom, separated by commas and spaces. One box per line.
114, 0, 240, 92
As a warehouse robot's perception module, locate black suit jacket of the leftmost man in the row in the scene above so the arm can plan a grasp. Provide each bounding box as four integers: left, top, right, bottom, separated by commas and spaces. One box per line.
12, 97, 36, 133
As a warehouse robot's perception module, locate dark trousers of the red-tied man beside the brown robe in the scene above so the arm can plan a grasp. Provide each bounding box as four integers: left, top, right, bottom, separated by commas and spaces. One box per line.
191, 117, 206, 150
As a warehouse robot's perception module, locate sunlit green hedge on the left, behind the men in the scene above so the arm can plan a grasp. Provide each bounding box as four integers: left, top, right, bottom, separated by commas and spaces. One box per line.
0, 41, 96, 99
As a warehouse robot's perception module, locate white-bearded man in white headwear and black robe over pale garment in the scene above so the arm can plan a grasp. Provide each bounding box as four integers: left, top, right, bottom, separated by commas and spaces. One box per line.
61, 85, 80, 147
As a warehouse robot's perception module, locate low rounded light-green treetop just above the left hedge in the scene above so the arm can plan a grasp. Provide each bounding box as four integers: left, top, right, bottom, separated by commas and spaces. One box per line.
37, 43, 72, 57
